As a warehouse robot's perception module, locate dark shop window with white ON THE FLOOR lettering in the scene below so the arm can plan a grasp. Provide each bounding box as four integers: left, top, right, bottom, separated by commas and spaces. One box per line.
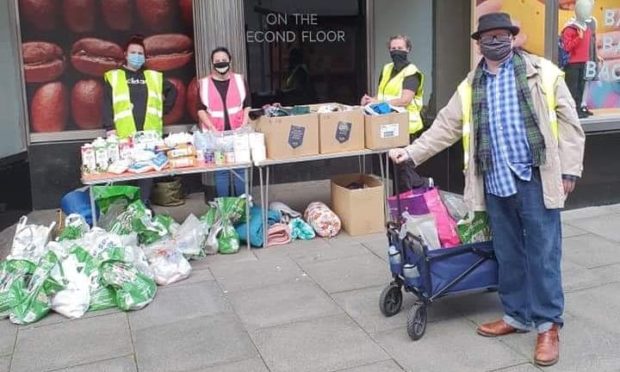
244, 0, 367, 107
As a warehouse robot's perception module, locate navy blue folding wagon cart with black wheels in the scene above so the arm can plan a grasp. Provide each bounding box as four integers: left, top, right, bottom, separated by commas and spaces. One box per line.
379, 166, 498, 340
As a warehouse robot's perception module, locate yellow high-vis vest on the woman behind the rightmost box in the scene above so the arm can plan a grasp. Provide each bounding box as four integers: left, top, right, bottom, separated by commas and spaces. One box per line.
377, 63, 424, 134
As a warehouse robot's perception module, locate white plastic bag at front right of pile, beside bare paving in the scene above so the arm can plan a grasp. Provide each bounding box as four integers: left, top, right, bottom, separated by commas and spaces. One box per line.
144, 239, 192, 285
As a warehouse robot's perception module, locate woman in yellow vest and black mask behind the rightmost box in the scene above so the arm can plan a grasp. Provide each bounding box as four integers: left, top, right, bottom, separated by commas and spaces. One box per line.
361, 35, 424, 134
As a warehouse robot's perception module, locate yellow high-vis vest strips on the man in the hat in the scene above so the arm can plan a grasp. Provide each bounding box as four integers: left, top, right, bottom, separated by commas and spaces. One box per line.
457, 58, 564, 169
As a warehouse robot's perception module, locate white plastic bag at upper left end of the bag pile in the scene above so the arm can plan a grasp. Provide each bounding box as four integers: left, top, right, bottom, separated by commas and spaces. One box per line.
7, 216, 56, 263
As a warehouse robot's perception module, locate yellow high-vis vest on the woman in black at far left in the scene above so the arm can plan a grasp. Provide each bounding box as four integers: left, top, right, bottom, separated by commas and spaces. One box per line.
104, 69, 164, 139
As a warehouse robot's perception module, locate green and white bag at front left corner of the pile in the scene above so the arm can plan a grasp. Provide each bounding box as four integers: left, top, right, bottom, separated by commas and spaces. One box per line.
10, 251, 62, 324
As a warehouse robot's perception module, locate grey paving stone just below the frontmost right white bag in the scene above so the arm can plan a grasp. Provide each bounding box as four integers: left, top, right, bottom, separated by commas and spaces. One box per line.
128, 281, 232, 332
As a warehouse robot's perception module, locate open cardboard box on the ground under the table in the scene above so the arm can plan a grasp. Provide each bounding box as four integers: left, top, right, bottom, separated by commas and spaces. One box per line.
331, 174, 385, 235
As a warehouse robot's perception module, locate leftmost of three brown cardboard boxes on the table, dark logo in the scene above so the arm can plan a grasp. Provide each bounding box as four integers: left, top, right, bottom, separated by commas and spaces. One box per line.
256, 113, 319, 160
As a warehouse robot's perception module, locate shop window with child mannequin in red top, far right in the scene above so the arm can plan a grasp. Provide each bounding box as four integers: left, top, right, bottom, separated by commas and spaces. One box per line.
558, 0, 620, 119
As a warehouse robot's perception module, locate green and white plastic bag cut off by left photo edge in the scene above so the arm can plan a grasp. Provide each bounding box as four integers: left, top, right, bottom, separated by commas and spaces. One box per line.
0, 260, 36, 319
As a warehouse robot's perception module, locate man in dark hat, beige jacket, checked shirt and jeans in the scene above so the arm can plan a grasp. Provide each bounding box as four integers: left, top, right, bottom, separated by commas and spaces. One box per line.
390, 13, 585, 366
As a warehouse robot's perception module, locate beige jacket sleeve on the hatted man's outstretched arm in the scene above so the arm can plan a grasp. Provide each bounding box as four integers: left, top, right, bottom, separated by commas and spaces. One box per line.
406, 87, 463, 165
